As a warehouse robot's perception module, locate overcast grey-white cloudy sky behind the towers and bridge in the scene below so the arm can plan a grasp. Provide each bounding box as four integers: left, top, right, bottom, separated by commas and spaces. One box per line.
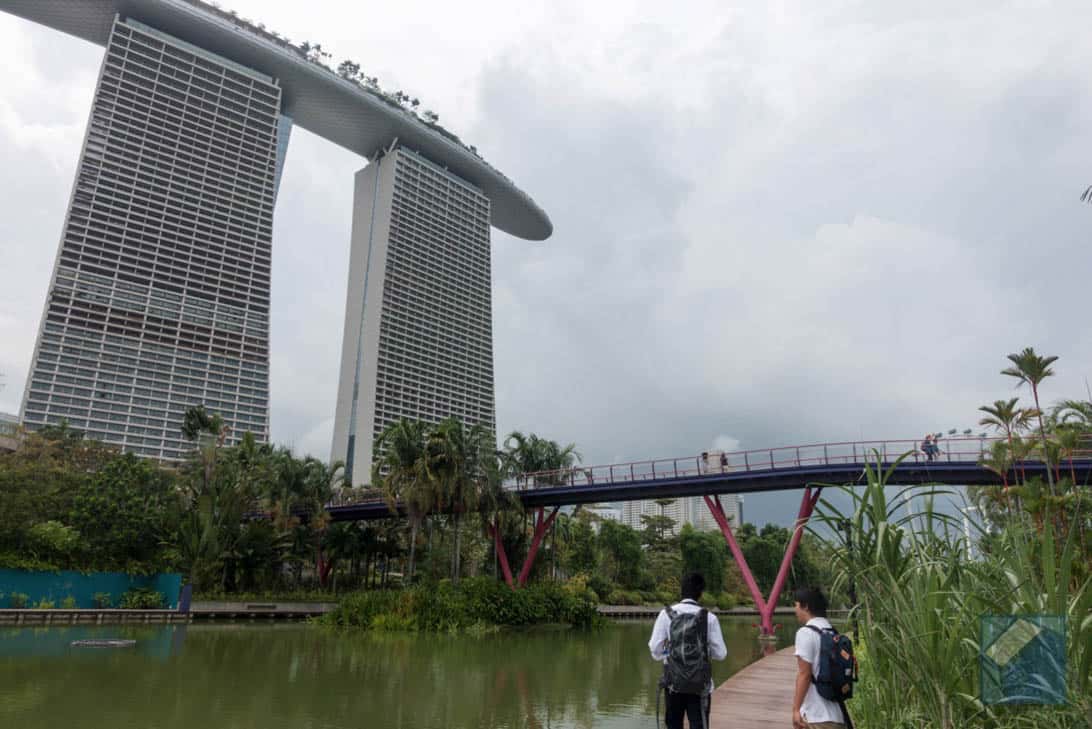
0, 0, 1092, 523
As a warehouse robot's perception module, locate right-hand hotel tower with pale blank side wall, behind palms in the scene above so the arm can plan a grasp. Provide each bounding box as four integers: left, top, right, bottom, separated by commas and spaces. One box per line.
331, 145, 496, 485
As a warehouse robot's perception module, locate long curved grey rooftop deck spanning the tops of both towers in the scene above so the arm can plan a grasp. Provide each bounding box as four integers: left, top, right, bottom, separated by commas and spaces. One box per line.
0, 0, 554, 240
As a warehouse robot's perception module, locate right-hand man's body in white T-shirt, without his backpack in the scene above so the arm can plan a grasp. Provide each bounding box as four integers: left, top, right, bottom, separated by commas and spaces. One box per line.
793, 587, 845, 729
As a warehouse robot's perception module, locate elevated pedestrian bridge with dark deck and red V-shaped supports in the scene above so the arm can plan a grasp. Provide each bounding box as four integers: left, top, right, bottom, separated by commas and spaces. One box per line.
328, 438, 1092, 638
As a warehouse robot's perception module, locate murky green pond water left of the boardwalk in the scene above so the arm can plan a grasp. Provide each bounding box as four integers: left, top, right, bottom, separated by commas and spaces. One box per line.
0, 619, 792, 729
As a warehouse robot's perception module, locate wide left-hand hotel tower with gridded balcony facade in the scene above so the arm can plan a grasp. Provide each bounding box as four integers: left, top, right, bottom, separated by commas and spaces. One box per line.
22, 16, 290, 459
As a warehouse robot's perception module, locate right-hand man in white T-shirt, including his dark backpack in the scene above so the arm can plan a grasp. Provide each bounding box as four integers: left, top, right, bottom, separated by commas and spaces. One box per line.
793, 587, 857, 729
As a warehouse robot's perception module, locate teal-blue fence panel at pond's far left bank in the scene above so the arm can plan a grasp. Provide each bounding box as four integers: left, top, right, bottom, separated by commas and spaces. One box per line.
0, 570, 182, 610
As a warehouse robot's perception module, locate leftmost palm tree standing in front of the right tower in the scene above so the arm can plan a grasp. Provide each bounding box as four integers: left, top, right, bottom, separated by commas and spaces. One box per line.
371, 418, 435, 581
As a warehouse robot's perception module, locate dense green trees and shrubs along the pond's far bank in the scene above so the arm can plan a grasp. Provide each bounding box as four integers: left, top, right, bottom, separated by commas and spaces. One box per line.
0, 408, 826, 608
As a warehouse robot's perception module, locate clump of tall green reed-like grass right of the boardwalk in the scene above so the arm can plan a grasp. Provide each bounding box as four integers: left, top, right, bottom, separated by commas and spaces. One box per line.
817, 451, 1092, 729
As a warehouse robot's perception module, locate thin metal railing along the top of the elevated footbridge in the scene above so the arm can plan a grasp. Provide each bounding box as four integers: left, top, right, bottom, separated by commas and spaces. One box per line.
507, 437, 1092, 490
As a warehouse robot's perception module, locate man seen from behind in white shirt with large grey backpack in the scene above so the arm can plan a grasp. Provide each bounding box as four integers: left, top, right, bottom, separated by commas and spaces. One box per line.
649, 573, 728, 729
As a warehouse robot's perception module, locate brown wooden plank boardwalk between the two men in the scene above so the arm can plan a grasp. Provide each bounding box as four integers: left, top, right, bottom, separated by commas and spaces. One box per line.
709, 646, 796, 729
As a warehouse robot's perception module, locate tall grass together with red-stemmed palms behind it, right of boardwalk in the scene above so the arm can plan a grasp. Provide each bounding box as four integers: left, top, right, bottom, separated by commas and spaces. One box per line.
819, 349, 1092, 729
